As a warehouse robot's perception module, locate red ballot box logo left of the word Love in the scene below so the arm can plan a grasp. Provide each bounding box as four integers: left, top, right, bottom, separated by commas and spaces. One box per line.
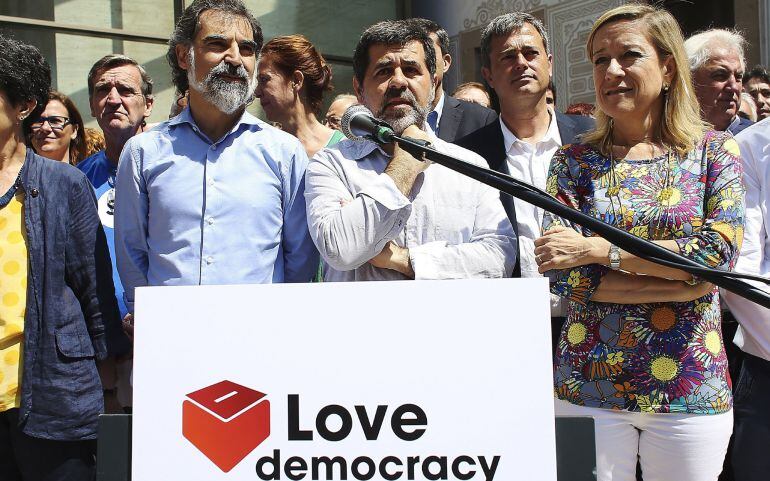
182, 381, 270, 472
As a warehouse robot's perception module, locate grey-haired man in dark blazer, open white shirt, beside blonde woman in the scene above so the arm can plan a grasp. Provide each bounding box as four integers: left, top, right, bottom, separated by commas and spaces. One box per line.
456, 12, 594, 344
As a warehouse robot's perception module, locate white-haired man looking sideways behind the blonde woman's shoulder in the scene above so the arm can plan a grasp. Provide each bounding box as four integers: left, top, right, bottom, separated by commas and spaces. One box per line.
684, 29, 752, 135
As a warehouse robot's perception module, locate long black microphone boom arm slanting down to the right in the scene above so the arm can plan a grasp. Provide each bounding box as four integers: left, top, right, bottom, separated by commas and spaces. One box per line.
393, 135, 770, 309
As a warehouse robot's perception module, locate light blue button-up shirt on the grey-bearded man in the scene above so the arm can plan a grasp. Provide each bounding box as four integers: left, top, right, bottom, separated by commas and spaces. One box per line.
115, 108, 318, 312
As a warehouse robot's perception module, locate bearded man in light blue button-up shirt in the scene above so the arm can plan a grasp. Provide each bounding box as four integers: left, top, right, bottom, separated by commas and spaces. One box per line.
115, 0, 318, 311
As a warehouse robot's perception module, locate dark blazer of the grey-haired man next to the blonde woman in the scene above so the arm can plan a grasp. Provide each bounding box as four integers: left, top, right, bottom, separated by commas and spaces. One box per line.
455, 112, 595, 277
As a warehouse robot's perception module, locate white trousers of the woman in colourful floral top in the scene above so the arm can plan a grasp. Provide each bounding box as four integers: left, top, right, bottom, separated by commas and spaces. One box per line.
555, 399, 733, 481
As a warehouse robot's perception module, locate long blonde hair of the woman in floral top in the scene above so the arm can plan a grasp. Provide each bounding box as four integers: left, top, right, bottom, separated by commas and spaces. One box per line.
583, 3, 708, 155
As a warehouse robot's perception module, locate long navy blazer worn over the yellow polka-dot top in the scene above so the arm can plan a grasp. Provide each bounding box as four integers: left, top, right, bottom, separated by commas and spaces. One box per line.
19, 149, 128, 441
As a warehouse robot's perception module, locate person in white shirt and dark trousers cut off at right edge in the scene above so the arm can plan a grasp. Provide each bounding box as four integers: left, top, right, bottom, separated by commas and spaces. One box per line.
722, 119, 770, 481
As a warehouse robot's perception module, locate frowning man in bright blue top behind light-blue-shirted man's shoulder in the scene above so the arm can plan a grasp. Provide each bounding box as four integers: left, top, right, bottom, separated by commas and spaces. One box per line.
77, 55, 153, 409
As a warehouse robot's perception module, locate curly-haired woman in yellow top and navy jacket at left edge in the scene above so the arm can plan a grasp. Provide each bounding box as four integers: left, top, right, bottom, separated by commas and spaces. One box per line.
0, 35, 128, 481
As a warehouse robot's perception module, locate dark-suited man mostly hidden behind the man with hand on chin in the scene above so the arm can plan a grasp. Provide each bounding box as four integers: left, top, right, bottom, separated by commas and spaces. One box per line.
411, 18, 497, 142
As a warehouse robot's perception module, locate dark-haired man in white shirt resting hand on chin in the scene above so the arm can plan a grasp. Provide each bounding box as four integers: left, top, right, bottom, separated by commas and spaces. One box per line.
305, 21, 516, 281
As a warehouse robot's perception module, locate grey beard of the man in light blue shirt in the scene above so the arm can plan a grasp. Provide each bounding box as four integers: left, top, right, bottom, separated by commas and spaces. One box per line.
187, 48, 257, 114
